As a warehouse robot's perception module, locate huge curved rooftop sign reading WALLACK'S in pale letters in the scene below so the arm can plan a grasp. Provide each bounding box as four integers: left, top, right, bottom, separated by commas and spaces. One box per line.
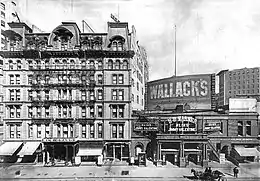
147, 74, 215, 110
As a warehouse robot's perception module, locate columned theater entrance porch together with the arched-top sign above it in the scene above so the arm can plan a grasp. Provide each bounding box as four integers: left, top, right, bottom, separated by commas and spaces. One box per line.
156, 116, 208, 167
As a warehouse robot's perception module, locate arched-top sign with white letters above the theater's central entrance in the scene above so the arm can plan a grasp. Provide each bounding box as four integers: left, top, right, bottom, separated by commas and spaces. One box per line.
168, 116, 197, 132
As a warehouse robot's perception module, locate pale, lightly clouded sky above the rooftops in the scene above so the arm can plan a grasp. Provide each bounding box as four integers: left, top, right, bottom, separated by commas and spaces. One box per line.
15, 0, 260, 81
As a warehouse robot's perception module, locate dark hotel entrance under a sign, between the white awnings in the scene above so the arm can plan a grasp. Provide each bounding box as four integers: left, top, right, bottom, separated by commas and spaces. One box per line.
43, 138, 79, 166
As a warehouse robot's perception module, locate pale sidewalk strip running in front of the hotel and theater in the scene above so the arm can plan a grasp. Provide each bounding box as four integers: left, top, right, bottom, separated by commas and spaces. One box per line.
0, 161, 260, 178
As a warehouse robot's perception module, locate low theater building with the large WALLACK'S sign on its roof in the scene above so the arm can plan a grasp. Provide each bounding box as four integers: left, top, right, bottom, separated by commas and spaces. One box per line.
132, 75, 260, 167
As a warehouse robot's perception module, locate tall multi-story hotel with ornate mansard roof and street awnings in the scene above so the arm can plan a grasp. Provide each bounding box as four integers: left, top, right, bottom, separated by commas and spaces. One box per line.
0, 22, 147, 164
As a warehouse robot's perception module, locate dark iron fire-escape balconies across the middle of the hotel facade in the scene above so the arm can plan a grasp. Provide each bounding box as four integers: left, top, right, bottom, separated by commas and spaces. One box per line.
30, 62, 95, 123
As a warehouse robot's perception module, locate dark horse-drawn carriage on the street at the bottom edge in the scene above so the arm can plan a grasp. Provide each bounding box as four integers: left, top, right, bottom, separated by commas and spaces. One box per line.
184, 169, 227, 181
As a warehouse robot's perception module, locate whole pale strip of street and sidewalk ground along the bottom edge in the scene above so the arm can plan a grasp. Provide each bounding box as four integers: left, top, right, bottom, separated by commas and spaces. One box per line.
0, 162, 260, 181
